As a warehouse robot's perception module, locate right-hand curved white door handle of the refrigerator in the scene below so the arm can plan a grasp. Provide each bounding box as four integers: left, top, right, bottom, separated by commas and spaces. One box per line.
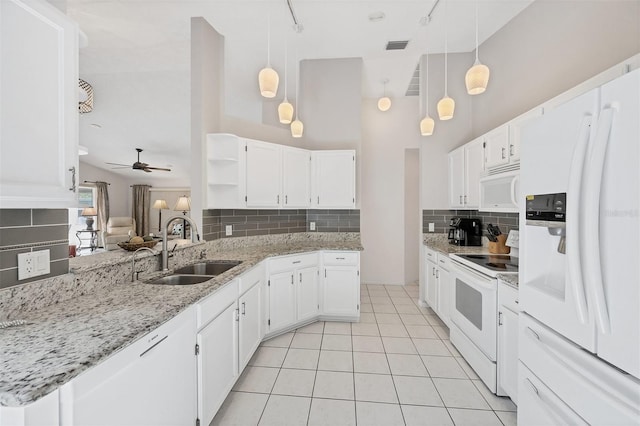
583, 106, 616, 334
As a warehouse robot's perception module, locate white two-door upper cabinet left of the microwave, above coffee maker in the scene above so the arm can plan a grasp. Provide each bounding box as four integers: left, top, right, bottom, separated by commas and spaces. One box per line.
449, 138, 484, 209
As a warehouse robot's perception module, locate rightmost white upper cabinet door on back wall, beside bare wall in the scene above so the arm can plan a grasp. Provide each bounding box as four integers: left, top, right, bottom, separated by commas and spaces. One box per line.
311, 150, 356, 209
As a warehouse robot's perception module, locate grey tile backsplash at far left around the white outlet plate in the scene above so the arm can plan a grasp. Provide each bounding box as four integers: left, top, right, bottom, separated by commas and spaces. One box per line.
0, 209, 69, 289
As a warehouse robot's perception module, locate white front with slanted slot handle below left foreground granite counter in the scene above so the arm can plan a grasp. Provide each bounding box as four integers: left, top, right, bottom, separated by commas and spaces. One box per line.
60, 308, 196, 426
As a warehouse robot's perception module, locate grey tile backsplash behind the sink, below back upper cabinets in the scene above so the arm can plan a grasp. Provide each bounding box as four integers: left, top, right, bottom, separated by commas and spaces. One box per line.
202, 209, 360, 241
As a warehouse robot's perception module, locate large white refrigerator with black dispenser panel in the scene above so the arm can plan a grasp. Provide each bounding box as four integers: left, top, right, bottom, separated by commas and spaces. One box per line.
518, 70, 640, 426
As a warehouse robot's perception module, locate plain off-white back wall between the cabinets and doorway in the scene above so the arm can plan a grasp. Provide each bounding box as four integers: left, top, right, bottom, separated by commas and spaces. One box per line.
360, 97, 425, 284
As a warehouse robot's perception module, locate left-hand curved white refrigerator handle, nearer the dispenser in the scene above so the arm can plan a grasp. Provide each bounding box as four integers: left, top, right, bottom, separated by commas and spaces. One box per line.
566, 115, 593, 324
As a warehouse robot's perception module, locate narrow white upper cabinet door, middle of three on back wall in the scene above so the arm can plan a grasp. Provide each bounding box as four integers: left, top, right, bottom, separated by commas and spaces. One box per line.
280, 146, 311, 209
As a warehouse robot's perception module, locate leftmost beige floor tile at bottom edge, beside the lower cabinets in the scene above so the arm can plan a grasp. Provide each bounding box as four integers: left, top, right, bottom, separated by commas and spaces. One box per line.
211, 392, 269, 426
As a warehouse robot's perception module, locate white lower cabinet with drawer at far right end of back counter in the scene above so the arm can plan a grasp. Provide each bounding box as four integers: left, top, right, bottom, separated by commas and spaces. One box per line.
322, 252, 360, 320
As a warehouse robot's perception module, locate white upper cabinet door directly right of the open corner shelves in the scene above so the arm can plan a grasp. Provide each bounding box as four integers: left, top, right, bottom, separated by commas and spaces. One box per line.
246, 139, 282, 208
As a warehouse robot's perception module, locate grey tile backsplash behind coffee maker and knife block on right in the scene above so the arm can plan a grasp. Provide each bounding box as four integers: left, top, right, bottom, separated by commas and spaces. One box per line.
422, 210, 519, 235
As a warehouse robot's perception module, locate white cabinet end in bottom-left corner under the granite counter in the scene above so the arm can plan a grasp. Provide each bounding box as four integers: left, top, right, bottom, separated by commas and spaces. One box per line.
0, 390, 60, 426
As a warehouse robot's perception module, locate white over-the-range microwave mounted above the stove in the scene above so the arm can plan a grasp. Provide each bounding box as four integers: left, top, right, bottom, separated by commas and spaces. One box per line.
478, 164, 520, 213
